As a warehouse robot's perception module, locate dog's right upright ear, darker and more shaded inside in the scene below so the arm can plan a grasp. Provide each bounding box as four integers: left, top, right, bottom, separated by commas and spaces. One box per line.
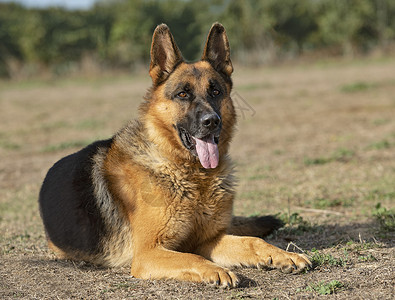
202, 23, 233, 76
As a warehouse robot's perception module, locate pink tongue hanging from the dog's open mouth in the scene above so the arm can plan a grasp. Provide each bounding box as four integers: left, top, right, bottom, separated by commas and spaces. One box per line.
194, 135, 219, 169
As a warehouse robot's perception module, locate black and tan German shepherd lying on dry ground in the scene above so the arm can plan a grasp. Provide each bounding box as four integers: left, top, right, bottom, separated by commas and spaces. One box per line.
39, 23, 311, 287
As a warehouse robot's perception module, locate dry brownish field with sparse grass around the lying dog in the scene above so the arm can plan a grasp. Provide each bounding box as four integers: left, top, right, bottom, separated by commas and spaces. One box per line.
0, 58, 395, 299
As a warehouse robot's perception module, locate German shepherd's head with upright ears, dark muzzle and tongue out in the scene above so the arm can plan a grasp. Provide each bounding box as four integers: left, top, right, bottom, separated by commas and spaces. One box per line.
143, 23, 236, 169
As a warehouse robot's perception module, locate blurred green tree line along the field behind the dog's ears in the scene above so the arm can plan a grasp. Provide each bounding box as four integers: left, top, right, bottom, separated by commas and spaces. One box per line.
0, 0, 395, 77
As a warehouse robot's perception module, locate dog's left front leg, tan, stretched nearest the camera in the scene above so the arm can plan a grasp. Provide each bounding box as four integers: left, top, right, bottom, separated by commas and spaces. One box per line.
131, 247, 239, 287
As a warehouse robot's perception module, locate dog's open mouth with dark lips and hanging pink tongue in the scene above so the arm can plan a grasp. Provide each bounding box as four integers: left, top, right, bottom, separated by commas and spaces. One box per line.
178, 127, 219, 169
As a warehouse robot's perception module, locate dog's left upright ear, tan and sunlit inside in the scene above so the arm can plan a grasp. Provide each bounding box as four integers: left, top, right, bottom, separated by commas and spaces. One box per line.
149, 24, 183, 85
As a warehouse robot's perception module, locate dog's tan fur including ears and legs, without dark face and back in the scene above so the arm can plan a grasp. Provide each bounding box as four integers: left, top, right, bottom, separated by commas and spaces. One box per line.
47, 24, 310, 287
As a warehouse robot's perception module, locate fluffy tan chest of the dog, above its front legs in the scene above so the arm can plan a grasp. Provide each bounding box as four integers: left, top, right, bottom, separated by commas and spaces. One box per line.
158, 175, 233, 251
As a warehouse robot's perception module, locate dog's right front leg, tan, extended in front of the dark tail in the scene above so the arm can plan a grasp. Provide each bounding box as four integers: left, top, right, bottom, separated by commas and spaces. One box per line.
197, 235, 311, 273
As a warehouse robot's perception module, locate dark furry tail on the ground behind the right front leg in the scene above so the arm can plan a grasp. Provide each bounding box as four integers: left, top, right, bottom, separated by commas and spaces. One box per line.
228, 216, 284, 237
